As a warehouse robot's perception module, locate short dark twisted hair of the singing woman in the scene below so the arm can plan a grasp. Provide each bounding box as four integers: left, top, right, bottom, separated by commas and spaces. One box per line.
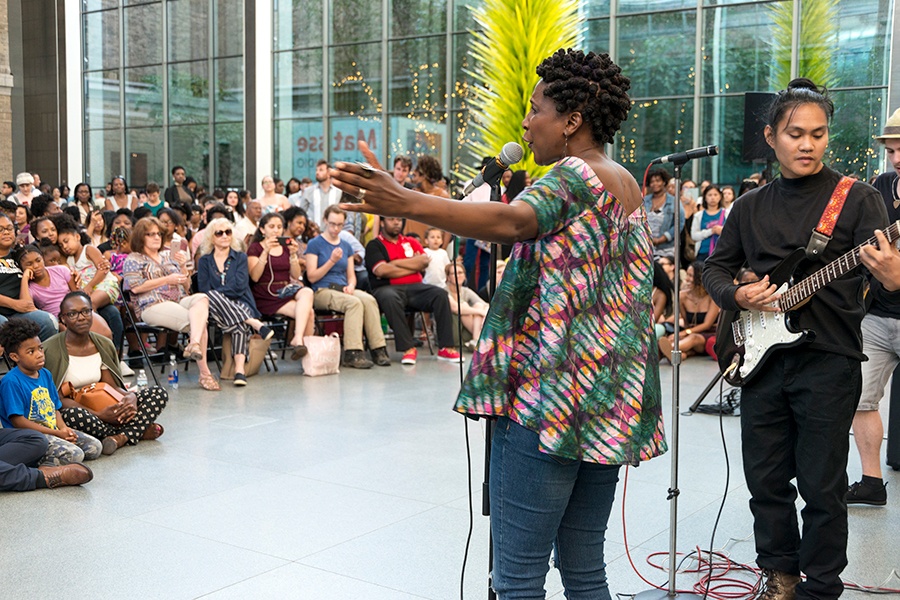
537, 48, 631, 144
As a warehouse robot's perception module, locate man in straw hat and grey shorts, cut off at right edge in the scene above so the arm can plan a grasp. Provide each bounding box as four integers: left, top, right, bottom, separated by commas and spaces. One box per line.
847, 109, 900, 506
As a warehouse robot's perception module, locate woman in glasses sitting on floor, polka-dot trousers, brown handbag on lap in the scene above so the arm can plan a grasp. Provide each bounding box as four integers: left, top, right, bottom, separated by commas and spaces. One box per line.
44, 290, 169, 454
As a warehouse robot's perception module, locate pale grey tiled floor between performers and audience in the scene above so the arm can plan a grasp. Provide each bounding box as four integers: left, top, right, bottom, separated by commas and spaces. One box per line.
0, 353, 900, 600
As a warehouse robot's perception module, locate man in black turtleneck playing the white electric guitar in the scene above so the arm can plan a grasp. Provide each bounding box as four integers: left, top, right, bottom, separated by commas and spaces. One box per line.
703, 79, 887, 600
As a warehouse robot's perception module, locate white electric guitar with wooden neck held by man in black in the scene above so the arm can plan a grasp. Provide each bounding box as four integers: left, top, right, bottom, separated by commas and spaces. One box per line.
715, 221, 900, 386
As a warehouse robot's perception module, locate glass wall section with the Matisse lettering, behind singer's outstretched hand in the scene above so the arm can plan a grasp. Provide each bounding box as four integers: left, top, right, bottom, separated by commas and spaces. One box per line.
273, 0, 458, 184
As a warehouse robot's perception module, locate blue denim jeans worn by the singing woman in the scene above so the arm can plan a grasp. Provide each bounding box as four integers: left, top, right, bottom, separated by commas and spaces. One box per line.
490, 417, 619, 600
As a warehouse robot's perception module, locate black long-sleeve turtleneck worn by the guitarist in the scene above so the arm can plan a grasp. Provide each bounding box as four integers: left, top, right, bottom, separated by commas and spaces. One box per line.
703, 167, 888, 360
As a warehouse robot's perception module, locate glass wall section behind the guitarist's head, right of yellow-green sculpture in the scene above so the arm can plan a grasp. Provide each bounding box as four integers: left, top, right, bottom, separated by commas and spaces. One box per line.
612, 0, 892, 184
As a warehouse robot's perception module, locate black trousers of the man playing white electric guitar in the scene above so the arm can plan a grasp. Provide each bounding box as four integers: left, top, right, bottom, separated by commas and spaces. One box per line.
741, 348, 862, 598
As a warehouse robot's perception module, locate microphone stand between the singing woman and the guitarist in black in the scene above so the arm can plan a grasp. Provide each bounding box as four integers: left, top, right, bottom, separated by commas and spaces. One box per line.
635, 155, 703, 600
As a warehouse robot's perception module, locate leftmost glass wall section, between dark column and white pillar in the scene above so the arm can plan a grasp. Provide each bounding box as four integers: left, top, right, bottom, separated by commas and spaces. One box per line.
82, 0, 245, 189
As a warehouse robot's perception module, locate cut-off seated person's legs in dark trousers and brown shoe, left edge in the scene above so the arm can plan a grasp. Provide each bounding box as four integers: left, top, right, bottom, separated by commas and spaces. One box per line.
0, 427, 94, 492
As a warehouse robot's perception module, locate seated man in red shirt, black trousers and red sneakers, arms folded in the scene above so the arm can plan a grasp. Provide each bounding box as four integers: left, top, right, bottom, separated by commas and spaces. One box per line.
366, 217, 462, 365
